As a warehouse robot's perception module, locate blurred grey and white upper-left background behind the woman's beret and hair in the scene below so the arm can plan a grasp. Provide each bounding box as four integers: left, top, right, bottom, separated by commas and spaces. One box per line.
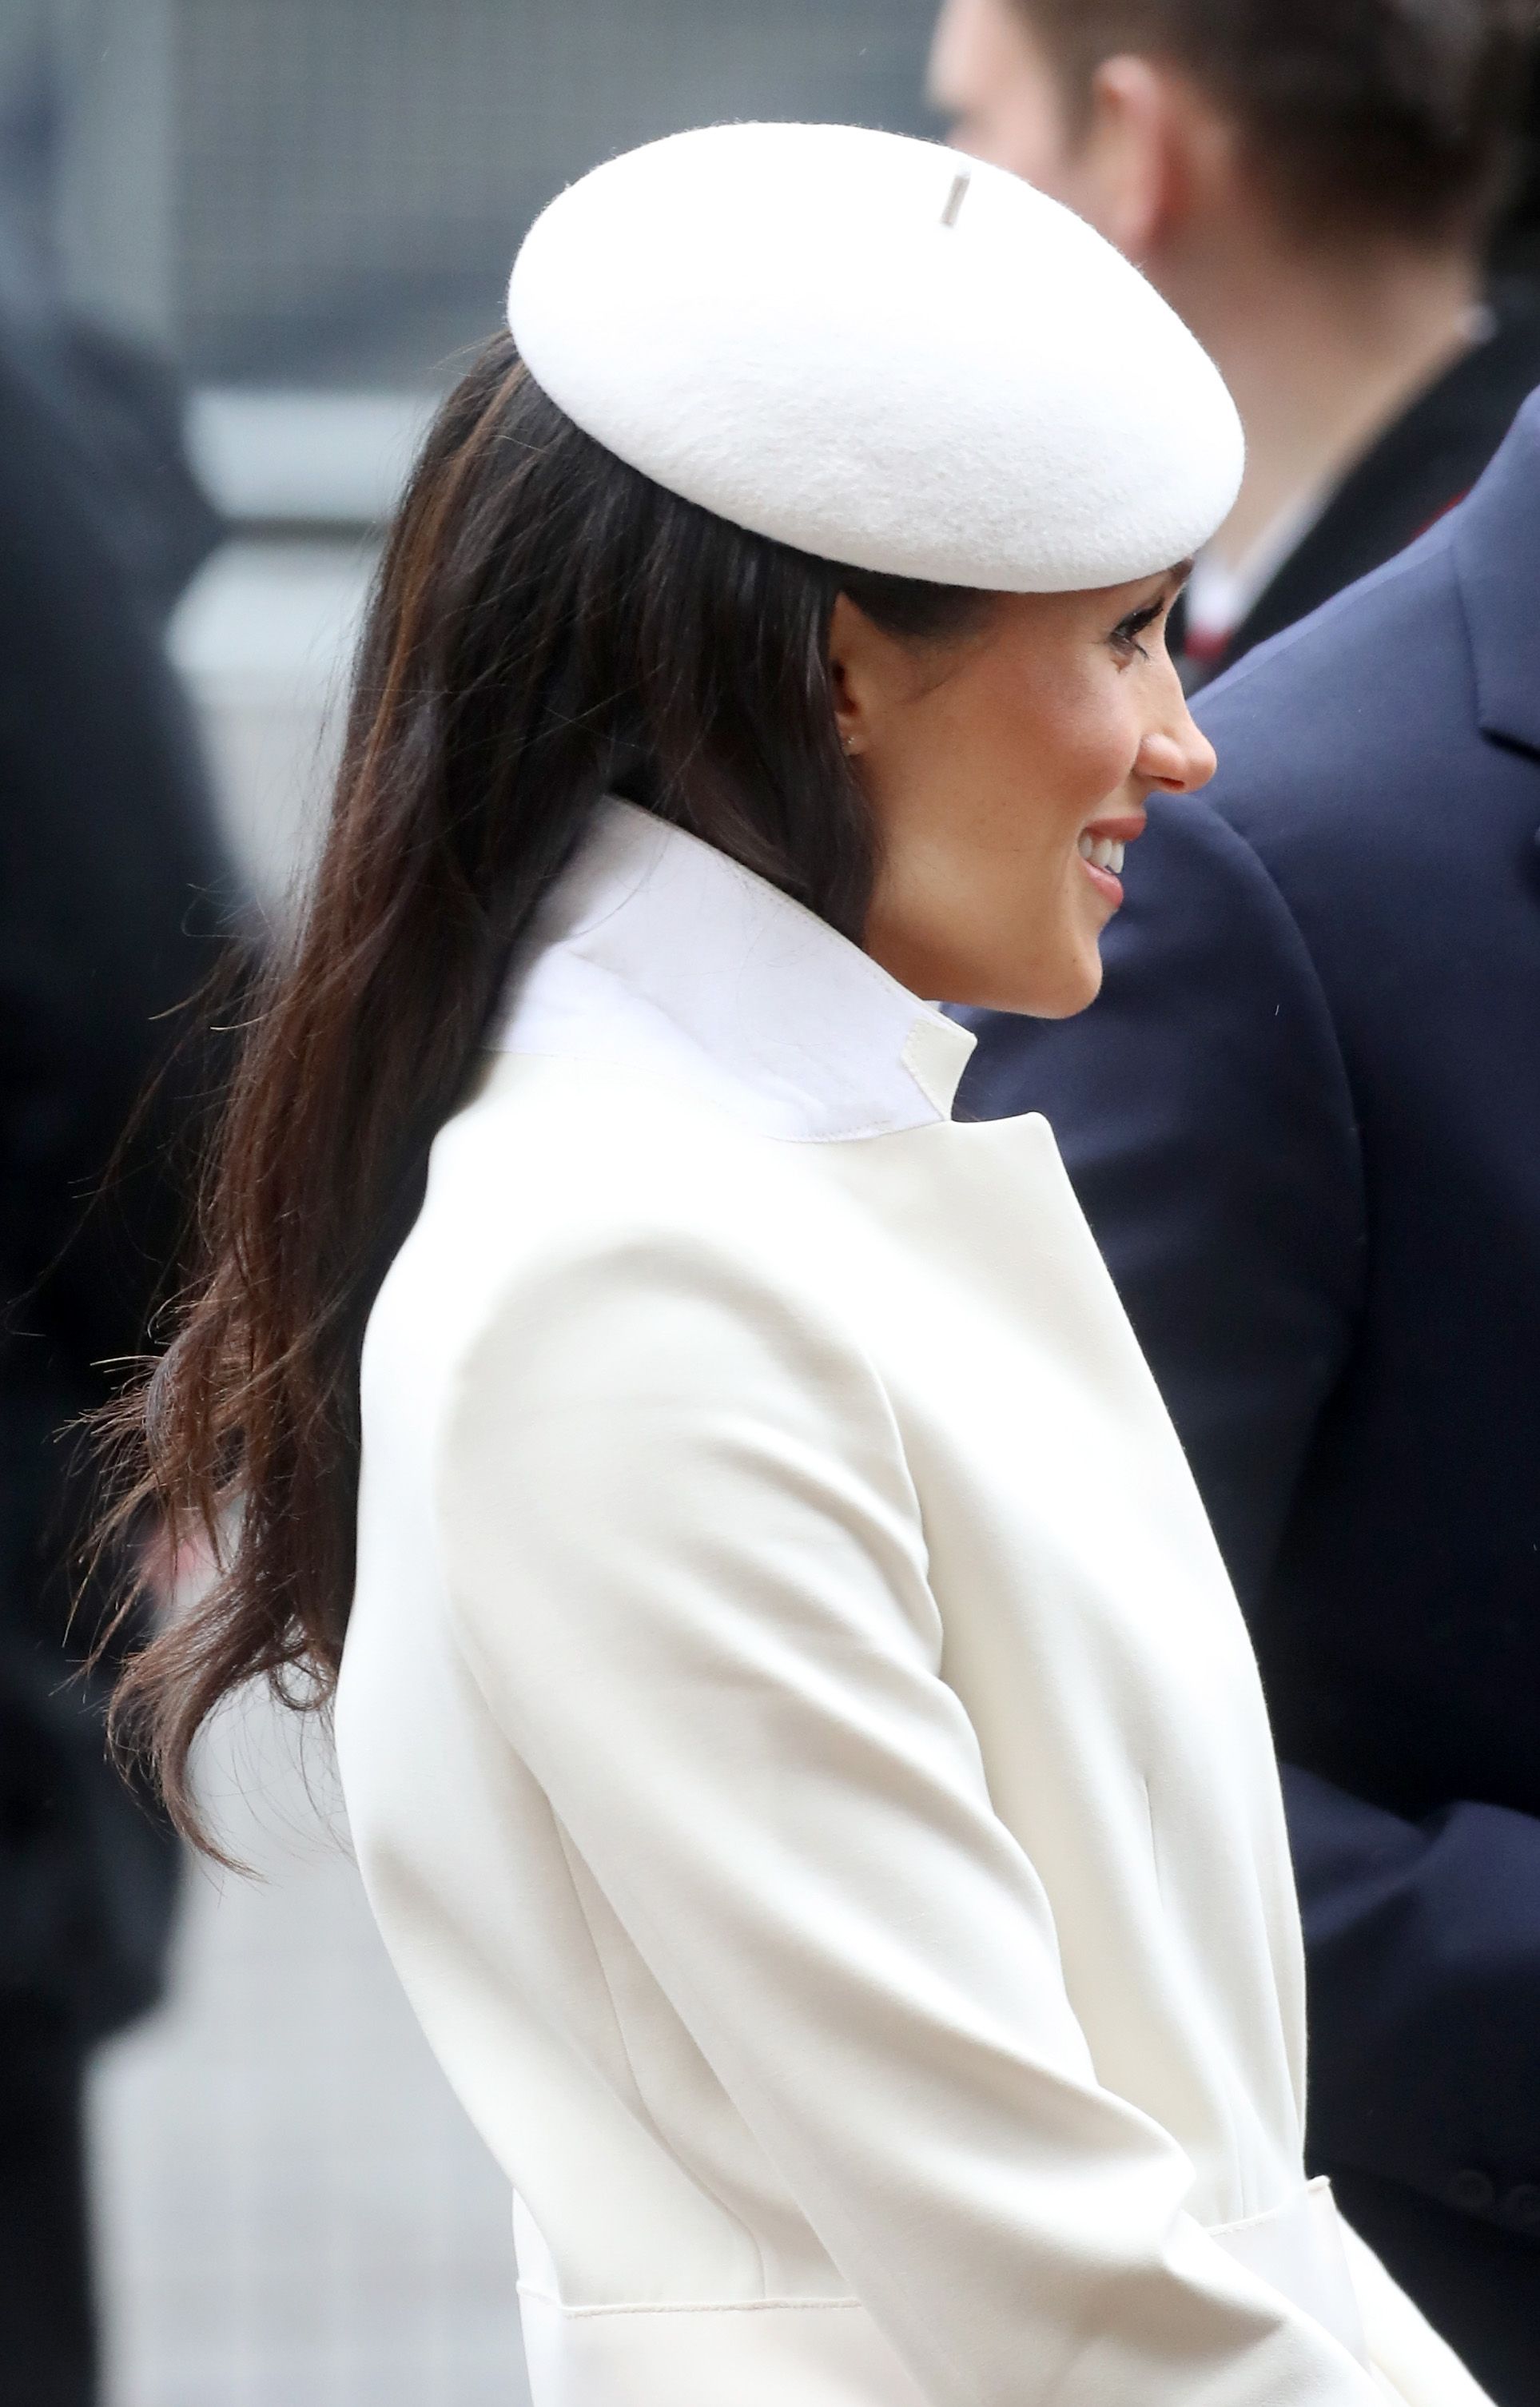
0, 0, 933, 919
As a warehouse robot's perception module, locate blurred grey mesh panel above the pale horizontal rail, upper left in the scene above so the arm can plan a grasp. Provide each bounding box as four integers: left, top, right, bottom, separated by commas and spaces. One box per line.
12, 0, 933, 388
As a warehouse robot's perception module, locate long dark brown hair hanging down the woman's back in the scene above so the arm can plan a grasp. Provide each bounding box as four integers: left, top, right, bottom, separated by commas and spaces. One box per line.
108, 337, 979, 1844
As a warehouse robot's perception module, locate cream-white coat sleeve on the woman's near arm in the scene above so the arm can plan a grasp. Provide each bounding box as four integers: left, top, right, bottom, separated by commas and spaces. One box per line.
438, 1239, 1379, 2407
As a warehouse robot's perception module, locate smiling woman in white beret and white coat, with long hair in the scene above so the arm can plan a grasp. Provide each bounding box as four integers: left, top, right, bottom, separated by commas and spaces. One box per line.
105, 128, 1480, 2407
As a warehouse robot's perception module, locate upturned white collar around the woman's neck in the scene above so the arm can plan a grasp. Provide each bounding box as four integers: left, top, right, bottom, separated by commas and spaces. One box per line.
493, 802, 974, 1141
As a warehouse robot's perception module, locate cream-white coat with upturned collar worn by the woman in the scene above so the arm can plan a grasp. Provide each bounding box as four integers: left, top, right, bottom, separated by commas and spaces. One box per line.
337, 804, 1482, 2407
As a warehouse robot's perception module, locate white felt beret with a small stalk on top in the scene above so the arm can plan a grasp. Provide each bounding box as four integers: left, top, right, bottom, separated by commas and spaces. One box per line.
507, 125, 1242, 592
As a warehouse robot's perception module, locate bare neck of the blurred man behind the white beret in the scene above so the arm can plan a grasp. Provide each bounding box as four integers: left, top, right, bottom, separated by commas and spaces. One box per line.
1148, 226, 1480, 566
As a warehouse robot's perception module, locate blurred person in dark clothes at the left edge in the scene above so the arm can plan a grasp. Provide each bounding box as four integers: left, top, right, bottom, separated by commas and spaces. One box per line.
0, 320, 229, 2407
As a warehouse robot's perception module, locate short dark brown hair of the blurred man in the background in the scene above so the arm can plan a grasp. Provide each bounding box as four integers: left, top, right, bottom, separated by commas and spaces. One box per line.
1016, 0, 1540, 243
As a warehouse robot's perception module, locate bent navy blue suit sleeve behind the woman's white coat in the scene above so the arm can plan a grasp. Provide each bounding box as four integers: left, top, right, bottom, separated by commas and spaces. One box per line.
962, 802, 1540, 2262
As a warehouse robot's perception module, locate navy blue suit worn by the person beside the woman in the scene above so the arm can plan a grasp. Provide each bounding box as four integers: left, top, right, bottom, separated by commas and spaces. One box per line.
960, 395, 1540, 2407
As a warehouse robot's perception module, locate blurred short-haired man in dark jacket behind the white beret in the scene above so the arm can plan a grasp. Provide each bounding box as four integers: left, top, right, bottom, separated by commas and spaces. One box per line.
931, 0, 1540, 686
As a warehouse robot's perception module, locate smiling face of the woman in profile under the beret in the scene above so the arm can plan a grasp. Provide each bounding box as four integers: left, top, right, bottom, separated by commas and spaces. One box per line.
830, 563, 1216, 1018
